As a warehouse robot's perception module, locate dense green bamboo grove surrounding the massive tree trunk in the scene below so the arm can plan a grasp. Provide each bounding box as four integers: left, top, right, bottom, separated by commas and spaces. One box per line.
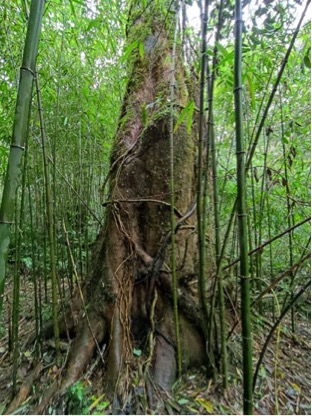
0, 0, 311, 414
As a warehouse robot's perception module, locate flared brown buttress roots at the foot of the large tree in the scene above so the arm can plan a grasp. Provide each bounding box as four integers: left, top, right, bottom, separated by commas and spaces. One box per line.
6, 276, 206, 414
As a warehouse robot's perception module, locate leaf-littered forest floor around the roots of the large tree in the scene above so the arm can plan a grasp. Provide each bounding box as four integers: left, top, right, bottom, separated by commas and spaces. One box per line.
0, 279, 311, 415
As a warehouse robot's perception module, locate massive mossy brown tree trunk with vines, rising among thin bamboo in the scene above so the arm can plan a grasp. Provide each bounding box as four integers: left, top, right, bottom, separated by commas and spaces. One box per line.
31, 2, 210, 413
